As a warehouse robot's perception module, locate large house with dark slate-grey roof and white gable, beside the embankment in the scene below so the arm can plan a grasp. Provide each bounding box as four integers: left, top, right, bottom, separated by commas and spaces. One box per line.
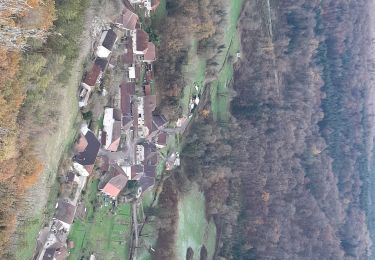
73, 125, 100, 176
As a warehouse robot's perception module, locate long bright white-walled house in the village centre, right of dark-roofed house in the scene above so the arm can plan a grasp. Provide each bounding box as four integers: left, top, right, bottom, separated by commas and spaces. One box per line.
100, 107, 121, 152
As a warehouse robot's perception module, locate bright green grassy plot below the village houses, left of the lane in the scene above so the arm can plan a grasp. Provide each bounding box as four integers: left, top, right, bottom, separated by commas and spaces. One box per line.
68, 181, 131, 260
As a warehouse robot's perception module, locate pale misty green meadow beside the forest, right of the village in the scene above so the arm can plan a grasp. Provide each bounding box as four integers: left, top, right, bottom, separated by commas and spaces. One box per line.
176, 186, 216, 260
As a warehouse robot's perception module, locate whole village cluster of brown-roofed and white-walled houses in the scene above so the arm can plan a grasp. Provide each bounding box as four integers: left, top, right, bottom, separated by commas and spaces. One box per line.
33, 0, 173, 260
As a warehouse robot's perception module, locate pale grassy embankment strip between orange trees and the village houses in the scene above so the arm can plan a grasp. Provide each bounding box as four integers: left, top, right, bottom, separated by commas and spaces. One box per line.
9, 0, 125, 259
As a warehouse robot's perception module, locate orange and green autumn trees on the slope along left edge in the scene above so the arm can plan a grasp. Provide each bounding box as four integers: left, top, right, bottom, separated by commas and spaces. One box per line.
0, 0, 86, 255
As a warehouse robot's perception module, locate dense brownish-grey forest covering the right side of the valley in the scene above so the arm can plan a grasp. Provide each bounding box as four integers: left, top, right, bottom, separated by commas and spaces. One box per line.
152, 0, 373, 260
